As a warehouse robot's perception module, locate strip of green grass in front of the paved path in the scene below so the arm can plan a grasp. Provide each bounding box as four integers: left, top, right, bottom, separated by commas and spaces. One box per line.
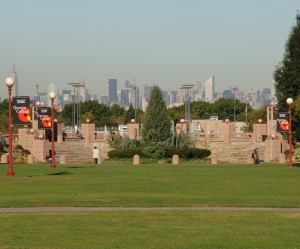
0, 211, 300, 249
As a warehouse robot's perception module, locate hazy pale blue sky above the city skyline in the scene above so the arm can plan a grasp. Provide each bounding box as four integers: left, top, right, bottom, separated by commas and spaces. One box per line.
0, 0, 300, 98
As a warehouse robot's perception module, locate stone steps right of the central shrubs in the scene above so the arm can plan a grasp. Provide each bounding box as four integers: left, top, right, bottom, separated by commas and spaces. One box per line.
209, 142, 265, 164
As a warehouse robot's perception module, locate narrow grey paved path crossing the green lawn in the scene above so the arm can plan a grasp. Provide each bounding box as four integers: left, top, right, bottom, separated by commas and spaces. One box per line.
0, 207, 300, 213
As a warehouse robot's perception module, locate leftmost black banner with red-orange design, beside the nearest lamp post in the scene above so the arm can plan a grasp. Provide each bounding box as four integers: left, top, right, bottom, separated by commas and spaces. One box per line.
12, 96, 31, 125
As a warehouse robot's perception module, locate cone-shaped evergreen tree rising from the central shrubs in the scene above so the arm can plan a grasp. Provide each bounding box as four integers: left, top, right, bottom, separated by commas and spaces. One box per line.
142, 85, 171, 143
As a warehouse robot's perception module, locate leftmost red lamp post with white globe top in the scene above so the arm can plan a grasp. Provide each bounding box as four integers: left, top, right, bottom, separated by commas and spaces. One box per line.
5, 77, 15, 176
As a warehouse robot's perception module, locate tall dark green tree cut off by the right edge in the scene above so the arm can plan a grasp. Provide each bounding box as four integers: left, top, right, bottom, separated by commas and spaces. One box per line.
273, 12, 300, 141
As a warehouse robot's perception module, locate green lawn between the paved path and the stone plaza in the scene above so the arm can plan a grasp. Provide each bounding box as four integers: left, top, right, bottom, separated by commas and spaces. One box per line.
0, 164, 300, 207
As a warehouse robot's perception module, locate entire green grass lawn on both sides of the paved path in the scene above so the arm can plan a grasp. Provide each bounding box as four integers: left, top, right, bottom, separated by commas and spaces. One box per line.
0, 164, 300, 249
